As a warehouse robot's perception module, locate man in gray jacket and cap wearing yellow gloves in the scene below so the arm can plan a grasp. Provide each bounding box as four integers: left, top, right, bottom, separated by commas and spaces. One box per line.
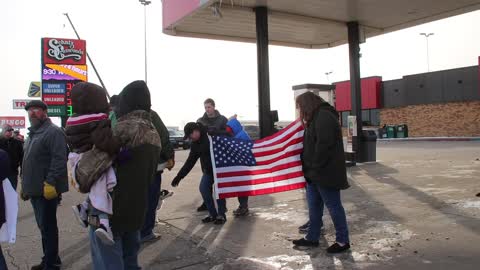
21, 100, 68, 270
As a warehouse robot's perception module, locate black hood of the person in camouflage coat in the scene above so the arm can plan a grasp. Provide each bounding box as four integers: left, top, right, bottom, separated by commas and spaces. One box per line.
118, 81, 152, 116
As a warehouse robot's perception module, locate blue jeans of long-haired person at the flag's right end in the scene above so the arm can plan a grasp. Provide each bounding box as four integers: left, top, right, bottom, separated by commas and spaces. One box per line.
305, 183, 350, 244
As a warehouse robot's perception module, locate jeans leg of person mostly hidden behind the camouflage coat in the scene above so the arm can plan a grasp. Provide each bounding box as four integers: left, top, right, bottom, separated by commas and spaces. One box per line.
140, 172, 162, 238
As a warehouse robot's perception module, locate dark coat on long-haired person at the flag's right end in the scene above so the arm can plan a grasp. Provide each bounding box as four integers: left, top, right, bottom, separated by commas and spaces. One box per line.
302, 102, 349, 190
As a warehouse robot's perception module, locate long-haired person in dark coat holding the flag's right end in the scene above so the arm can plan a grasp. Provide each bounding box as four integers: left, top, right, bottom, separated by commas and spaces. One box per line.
293, 92, 350, 253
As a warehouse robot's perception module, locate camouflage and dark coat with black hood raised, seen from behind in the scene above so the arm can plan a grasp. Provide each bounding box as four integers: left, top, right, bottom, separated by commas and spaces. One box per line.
112, 81, 161, 233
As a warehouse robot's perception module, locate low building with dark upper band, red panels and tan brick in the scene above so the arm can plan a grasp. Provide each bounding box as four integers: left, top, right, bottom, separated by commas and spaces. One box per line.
335, 58, 480, 137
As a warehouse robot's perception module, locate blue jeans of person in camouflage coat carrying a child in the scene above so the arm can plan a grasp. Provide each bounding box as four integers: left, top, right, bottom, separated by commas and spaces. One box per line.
89, 226, 141, 270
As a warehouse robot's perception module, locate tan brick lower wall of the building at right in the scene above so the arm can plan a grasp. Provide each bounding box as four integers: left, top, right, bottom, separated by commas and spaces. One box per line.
380, 101, 480, 137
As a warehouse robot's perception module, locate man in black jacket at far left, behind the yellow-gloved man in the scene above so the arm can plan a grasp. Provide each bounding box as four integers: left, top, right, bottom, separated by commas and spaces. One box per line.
0, 125, 23, 190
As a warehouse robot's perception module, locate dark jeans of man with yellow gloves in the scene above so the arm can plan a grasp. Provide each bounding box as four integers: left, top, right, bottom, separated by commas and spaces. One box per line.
30, 196, 61, 269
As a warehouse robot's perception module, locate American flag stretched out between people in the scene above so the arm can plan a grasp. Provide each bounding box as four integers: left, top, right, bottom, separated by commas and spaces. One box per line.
210, 121, 305, 199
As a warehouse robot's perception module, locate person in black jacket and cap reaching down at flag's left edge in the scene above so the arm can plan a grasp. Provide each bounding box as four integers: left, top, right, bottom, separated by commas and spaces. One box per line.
172, 122, 227, 225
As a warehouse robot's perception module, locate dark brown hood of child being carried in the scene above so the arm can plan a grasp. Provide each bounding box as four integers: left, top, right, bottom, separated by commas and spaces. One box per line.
71, 82, 110, 115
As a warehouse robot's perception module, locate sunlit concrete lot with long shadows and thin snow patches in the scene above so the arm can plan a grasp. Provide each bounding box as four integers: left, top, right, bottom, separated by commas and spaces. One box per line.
2, 142, 480, 270
